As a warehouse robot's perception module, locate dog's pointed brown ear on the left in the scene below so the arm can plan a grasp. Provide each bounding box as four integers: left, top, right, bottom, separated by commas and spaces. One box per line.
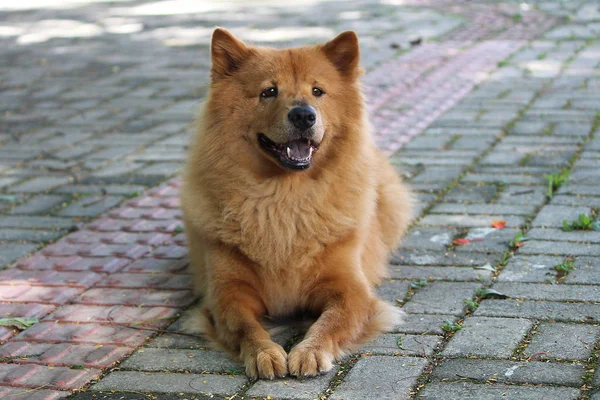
210, 28, 250, 79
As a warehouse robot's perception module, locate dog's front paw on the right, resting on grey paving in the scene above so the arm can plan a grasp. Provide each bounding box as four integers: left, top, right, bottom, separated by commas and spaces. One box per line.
288, 342, 334, 377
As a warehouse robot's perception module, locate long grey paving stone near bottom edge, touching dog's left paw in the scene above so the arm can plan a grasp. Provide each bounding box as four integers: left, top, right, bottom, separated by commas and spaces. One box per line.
90, 371, 247, 395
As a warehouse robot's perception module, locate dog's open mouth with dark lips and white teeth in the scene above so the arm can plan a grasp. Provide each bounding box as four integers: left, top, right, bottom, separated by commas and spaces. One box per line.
258, 133, 318, 170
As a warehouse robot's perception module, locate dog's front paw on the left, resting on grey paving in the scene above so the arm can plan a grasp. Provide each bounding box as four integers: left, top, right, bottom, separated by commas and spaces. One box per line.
242, 342, 288, 379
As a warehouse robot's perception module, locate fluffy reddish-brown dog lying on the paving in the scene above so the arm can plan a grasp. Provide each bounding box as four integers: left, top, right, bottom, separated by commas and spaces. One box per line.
181, 29, 412, 378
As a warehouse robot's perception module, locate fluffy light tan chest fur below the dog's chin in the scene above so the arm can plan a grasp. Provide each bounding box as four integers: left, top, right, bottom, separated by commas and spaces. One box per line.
220, 173, 364, 270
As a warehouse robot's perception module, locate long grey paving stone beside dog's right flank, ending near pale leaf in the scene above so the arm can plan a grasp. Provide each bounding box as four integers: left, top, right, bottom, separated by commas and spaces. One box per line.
390, 265, 491, 282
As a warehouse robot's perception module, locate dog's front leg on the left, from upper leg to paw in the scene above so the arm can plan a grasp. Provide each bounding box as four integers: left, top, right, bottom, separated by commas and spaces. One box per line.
205, 246, 287, 379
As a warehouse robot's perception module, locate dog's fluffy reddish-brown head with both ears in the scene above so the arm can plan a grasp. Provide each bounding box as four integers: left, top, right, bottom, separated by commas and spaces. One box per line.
207, 28, 362, 171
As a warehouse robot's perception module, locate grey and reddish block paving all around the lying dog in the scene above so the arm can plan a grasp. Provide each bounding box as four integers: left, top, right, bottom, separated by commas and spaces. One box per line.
0, 0, 600, 400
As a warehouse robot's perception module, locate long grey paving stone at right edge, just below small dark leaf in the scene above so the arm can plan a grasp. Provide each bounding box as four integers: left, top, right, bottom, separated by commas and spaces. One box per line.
474, 300, 600, 323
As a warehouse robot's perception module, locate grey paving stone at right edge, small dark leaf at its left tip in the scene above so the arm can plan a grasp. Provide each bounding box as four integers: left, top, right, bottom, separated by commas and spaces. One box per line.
494, 283, 600, 302
